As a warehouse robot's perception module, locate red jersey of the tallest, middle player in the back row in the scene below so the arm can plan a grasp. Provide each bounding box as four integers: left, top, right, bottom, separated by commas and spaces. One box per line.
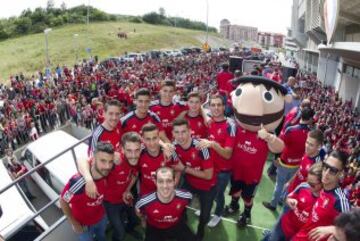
150, 100, 188, 140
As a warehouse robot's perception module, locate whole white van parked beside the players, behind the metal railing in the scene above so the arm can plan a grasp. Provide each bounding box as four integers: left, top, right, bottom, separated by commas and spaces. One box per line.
21, 130, 88, 207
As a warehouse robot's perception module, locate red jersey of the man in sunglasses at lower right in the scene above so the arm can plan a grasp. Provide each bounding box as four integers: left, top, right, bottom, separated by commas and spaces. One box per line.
291, 187, 350, 241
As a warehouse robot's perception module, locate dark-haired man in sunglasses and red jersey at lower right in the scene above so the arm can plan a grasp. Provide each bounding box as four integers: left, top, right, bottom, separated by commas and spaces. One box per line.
291, 151, 350, 241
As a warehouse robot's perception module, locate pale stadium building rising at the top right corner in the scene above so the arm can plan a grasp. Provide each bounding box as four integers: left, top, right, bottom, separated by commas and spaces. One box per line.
291, 0, 360, 108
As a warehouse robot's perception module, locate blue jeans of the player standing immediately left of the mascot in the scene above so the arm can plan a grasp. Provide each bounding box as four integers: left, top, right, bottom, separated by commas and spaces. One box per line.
215, 172, 231, 217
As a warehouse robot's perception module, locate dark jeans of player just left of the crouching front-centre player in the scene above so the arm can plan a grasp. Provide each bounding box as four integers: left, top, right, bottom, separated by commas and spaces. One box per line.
104, 201, 136, 241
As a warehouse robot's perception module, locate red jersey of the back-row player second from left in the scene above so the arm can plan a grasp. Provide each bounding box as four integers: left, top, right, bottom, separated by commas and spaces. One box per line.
120, 110, 164, 133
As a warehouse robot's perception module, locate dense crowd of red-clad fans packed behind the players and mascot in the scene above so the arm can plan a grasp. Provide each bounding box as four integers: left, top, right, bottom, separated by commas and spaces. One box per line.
0, 49, 360, 241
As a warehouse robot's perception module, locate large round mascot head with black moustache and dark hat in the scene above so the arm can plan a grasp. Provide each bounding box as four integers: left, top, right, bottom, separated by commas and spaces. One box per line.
231, 75, 287, 131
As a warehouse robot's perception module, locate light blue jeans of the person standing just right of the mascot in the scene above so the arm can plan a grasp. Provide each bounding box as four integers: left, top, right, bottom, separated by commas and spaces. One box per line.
270, 165, 298, 207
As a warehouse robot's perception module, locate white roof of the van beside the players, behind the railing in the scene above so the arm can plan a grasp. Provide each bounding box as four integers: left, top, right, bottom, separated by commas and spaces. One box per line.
26, 131, 88, 185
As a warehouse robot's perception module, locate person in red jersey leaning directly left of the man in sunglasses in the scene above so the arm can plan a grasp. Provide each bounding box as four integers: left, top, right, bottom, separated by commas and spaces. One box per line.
263, 163, 322, 241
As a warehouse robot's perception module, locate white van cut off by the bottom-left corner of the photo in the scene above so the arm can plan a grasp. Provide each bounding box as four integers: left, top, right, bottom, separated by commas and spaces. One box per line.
0, 160, 48, 241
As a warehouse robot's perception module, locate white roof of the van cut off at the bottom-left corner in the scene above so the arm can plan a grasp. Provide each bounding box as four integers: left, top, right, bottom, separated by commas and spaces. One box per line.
0, 160, 34, 238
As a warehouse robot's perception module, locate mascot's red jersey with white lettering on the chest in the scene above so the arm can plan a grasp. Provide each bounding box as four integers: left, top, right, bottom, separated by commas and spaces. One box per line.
231, 126, 269, 184
